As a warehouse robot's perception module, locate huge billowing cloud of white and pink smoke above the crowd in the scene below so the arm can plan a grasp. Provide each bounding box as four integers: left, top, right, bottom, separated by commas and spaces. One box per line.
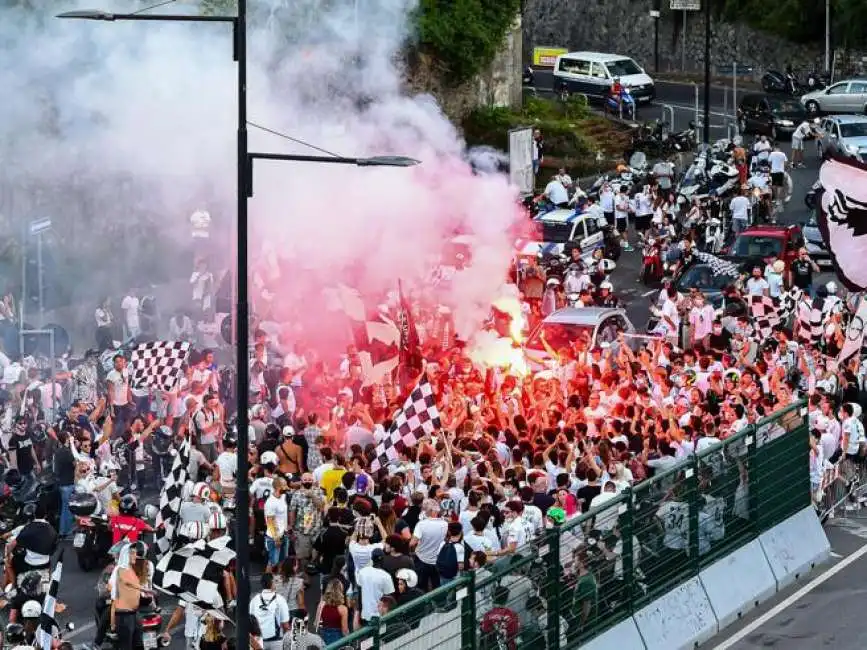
0, 0, 518, 354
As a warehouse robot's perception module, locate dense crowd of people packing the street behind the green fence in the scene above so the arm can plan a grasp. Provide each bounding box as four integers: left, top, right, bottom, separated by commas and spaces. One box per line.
0, 142, 867, 650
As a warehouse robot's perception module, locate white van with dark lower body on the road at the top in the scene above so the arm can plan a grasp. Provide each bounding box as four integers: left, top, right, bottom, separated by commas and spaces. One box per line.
554, 52, 656, 104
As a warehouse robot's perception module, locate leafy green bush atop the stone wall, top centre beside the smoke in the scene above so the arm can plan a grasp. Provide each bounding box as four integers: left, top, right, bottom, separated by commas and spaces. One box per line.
415, 0, 521, 85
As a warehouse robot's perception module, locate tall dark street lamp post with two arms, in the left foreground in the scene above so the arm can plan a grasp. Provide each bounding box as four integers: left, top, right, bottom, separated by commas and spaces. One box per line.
57, 7, 419, 648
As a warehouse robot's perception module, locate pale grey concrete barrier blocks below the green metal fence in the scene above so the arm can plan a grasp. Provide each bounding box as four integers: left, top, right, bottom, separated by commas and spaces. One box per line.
581, 507, 831, 650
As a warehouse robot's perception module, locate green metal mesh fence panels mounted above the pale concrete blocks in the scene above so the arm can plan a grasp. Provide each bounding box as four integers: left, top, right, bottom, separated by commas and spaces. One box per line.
328, 403, 811, 650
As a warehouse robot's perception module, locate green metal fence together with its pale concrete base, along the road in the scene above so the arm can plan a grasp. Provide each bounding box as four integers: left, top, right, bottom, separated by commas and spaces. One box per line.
328, 403, 830, 650
